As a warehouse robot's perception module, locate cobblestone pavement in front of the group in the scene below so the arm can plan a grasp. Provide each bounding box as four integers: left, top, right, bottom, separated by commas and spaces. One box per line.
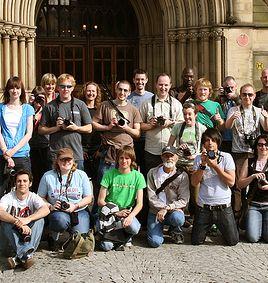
0, 229, 268, 283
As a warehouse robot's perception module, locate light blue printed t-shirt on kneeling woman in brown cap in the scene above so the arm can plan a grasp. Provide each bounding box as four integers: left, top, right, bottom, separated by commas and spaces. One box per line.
37, 169, 92, 210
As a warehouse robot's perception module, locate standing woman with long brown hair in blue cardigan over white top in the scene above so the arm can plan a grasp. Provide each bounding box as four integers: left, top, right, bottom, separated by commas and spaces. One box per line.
0, 77, 34, 196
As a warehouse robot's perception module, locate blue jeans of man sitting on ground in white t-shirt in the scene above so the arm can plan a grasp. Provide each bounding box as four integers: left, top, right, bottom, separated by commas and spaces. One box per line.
1, 218, 44, 259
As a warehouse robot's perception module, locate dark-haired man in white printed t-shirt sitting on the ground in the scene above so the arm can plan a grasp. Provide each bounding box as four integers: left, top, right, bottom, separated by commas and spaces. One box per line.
0, 169, 49, 269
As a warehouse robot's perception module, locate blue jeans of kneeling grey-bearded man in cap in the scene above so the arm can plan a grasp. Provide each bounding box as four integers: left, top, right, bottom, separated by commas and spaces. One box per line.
147, 211, 185, 248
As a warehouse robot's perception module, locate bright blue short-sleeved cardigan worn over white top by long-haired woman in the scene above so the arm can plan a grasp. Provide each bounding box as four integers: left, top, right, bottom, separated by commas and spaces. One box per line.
0, 103, 34, 157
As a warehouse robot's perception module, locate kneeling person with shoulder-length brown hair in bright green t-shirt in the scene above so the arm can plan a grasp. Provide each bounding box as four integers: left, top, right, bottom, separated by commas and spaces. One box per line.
98, 146, 146, 251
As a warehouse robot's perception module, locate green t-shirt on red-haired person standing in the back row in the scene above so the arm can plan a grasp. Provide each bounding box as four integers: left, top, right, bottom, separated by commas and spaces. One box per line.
196, 100, 225, 128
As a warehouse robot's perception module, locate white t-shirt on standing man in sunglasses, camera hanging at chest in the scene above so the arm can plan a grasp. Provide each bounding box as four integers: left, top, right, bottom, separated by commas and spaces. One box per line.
227, 106, 264, 153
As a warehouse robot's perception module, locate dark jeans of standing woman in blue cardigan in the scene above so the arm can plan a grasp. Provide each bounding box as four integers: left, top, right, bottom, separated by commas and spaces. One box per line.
0, 156, 31, 198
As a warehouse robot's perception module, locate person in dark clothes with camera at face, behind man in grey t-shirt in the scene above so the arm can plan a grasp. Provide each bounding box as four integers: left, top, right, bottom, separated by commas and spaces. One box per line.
29, 86, 52, 192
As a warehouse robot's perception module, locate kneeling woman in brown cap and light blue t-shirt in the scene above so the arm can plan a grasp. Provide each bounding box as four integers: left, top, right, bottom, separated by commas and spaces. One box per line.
38, 148, 92, 249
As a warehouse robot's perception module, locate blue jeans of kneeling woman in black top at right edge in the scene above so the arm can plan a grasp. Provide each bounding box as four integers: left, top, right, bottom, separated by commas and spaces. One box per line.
246, 203, 268, 243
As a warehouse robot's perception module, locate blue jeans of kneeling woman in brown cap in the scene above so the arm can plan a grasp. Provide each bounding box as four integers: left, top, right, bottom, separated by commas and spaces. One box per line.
48, 209, 90, 240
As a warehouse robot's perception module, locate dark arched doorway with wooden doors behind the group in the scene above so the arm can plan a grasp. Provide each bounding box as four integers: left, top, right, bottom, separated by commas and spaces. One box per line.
36, 0, 138, 88
